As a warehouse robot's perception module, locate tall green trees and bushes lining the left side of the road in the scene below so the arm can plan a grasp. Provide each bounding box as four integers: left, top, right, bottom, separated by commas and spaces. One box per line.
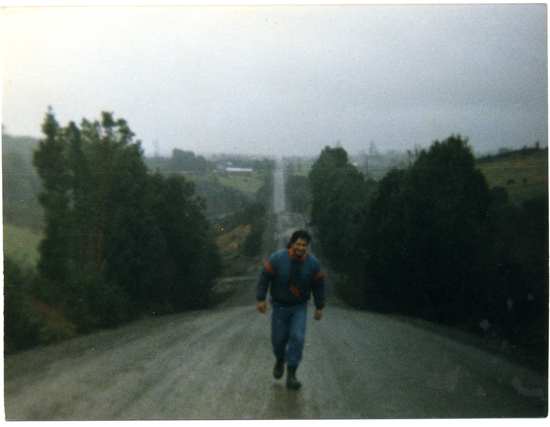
4, 110, 222, 350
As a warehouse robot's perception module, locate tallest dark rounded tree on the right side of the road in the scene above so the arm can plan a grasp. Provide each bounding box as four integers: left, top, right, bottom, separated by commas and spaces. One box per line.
368, 136, 491, 323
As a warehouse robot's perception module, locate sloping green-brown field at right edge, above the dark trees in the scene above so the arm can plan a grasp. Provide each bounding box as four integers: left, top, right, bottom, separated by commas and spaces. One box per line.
478, 150, 548, 203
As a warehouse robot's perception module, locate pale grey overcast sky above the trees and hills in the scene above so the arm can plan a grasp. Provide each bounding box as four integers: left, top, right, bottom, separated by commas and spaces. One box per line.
2, 4, 548, 155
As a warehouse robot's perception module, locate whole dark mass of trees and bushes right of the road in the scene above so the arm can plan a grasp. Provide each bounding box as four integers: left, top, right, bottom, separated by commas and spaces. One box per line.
308, 136, 548, 362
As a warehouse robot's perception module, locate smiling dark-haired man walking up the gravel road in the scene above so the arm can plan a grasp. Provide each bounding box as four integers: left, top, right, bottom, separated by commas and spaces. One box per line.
256, 230, 325, 390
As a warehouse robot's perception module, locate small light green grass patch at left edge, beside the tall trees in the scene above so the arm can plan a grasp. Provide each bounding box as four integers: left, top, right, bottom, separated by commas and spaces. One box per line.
3, 223, 41, 268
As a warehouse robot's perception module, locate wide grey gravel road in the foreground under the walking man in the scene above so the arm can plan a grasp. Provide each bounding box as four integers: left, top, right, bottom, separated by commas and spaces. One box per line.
4, 159, 548, 420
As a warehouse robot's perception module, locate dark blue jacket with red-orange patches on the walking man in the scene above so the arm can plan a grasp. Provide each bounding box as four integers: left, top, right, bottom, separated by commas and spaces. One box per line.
256, 248, 325, 310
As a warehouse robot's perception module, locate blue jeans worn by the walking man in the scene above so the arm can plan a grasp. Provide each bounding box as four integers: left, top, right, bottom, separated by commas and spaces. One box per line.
271, 302, 307, 367
